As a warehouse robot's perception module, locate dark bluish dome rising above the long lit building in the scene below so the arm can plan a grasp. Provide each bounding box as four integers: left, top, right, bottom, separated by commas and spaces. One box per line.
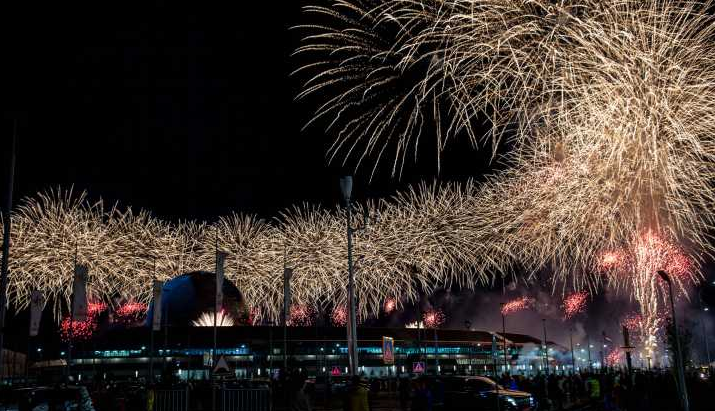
146, 271, 248, 327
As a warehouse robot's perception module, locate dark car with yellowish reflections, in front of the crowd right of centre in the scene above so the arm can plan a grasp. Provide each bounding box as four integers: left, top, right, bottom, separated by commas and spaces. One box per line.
437, 376, 536, 411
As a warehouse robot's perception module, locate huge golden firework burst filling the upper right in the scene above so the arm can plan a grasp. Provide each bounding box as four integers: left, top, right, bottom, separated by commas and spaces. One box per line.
298, 0, 715, 288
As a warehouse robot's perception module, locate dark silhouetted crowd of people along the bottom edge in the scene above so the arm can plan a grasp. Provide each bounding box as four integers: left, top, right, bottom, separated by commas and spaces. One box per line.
4, 369, 715, 411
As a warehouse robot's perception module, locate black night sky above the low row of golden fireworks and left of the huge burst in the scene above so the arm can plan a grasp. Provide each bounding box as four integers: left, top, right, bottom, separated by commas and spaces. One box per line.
1, 1, 485, 221
